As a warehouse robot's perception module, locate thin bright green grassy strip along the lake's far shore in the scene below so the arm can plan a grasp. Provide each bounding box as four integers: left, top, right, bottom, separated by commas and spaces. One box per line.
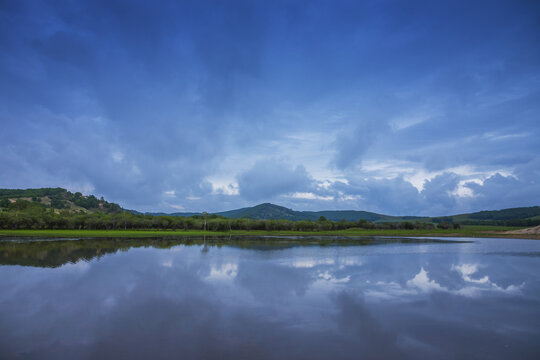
0, 225, 539, 239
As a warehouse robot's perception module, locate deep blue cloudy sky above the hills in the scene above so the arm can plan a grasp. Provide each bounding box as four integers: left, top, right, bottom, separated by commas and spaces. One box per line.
0, 0, 540, 216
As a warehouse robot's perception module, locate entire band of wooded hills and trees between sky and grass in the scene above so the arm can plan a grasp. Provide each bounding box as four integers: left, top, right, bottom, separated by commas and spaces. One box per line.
0, 188, 540, 231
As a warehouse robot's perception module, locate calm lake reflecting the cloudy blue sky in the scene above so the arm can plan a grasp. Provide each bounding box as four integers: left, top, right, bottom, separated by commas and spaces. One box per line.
0, 237, 540, 359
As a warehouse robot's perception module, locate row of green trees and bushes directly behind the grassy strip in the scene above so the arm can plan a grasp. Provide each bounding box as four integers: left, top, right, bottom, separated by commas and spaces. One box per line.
0, 199, 459, 231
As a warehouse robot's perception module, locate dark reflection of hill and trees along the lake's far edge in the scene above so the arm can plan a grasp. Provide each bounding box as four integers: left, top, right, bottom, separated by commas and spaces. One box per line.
0, 236, 468, 268
